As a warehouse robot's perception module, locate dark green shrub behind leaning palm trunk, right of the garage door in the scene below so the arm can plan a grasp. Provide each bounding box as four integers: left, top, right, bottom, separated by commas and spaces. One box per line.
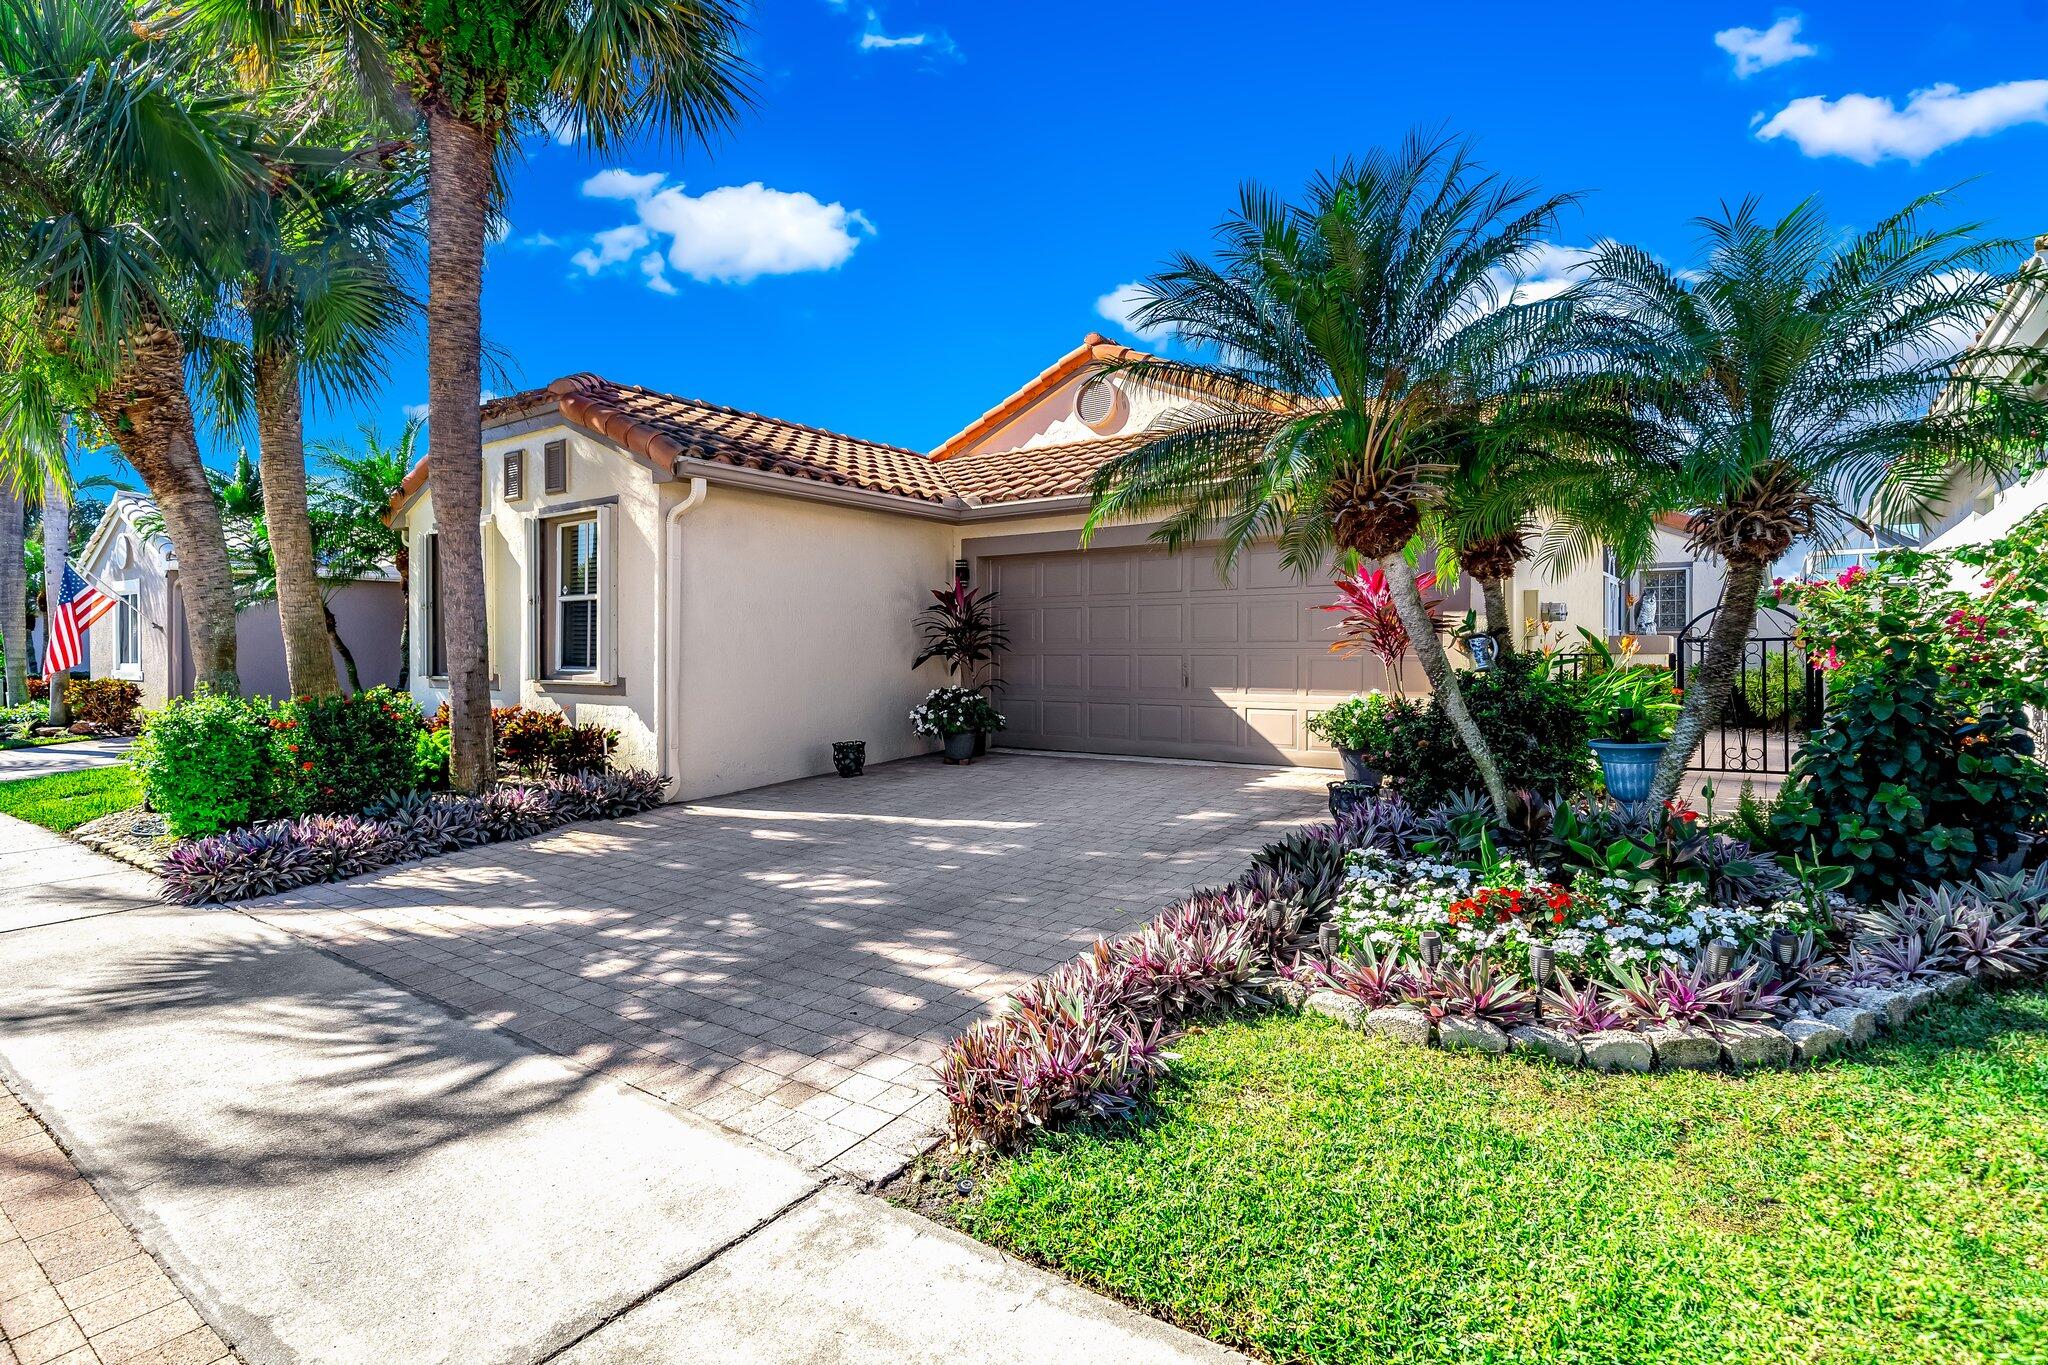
1382, 653, 1593, 810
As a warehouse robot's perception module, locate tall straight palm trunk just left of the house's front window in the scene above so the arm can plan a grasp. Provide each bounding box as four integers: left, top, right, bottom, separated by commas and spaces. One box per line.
426, 108, 492, 792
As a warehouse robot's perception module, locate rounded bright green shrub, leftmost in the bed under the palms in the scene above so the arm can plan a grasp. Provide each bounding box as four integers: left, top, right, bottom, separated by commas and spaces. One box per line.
129, 690, 303, 837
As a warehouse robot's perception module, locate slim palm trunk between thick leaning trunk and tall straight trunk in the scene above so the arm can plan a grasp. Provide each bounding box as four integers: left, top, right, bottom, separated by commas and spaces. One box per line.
256, 350, 342, 696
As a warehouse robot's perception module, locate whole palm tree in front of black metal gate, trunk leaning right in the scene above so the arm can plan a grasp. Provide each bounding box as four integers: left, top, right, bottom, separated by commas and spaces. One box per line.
1583, 192, 2048, 800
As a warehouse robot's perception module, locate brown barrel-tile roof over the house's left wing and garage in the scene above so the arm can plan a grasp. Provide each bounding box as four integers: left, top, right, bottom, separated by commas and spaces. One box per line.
393, 375, 1143, 510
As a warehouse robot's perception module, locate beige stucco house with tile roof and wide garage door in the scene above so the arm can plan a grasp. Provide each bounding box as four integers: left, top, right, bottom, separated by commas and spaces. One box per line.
391, 336, 1753, 798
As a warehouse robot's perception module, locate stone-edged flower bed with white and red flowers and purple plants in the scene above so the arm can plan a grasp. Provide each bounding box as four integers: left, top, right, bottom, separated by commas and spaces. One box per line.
940, 798, 2048, 1150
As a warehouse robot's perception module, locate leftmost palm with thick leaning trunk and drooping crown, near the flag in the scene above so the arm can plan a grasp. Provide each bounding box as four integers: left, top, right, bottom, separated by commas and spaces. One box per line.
0, 0, 256, 690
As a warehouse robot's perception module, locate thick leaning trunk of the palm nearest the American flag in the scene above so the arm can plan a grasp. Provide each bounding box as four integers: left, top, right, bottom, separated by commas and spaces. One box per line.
92, 325, 242, 694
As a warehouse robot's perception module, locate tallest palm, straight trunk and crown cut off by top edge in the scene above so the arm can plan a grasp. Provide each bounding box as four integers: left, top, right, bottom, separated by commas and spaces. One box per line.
197, 0, 748, 790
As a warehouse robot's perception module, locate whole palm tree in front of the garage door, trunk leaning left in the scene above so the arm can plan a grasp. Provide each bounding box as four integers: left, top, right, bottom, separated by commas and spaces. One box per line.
1083, 135, 1573, 810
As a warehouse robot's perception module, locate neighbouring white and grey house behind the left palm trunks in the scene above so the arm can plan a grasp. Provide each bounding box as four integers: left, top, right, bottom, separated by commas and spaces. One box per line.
78, 493, 406, 706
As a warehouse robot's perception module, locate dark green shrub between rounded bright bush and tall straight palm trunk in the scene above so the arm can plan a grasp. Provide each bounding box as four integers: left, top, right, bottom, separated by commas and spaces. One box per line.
270, 688, 422, 814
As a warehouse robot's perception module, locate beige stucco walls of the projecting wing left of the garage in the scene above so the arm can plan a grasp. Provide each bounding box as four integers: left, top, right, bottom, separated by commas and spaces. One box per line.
399, 424, 958, 800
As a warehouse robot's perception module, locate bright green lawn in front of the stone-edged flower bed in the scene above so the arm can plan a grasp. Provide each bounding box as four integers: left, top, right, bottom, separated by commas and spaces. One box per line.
946, 993, 2048, 1365
